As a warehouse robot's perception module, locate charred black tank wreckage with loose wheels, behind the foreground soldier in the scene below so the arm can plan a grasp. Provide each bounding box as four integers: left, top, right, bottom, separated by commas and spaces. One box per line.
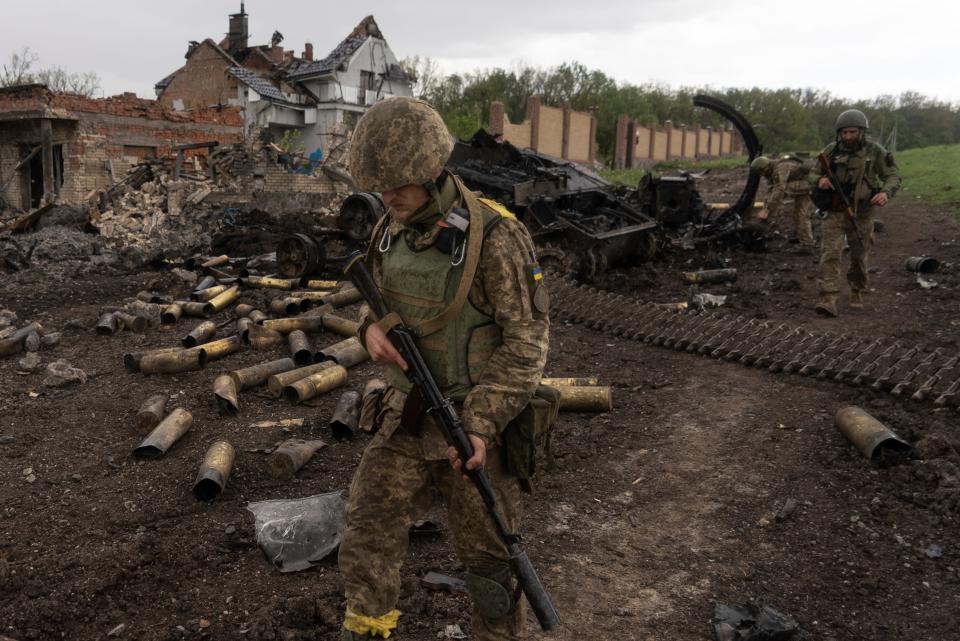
277, 95, 762, 281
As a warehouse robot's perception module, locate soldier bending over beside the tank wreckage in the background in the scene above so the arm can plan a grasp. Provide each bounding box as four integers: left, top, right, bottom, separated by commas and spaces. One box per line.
750, 154, 815, 254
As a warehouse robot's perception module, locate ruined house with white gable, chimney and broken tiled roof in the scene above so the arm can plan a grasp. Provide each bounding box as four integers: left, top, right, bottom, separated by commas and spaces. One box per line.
155, 4, 413, 154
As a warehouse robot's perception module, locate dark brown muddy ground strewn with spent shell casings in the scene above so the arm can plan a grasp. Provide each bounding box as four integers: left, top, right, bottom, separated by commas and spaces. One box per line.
0, 172, 960, 641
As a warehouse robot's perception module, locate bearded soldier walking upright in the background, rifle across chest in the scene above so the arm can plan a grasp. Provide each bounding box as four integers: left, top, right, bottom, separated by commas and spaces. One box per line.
810, 109, 900, 317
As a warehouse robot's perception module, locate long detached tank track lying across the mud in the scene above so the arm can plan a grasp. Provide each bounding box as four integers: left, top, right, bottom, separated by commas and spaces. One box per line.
550, 274, 960, 408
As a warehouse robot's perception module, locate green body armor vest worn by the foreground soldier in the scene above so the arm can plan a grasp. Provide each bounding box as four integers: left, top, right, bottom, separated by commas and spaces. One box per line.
380, 209, 502, 401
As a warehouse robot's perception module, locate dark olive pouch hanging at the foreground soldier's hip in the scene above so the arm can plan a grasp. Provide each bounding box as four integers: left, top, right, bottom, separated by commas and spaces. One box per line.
501, 385, 560, 492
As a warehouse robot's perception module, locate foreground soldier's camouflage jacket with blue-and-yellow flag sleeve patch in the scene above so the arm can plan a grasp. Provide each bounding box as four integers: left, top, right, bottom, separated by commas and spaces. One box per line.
360, 178, 550, 458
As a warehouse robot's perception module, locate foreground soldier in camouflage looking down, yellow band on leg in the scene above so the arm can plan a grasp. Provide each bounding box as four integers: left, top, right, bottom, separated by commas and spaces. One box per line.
339, 98, 549, 641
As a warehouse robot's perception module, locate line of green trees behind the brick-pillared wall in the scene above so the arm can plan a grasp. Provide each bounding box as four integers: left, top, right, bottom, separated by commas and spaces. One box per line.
403, 57, 960, 159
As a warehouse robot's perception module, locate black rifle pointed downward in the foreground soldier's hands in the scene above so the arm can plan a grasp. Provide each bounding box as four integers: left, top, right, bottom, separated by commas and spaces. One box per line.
343, 252, 560, 631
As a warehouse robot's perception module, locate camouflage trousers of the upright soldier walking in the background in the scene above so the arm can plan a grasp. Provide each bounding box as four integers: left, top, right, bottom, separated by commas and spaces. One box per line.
817, 207, 874, 296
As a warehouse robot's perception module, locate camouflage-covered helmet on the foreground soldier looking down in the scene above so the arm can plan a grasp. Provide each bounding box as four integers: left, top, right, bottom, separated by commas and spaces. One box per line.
349, 97, 453, 192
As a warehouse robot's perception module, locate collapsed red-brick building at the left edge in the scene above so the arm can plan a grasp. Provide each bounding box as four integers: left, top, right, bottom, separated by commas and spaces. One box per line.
0, 85, 243, 210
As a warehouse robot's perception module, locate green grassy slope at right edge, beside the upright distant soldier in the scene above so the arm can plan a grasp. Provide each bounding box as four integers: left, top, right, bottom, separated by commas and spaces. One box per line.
896, 145, 960, 215
